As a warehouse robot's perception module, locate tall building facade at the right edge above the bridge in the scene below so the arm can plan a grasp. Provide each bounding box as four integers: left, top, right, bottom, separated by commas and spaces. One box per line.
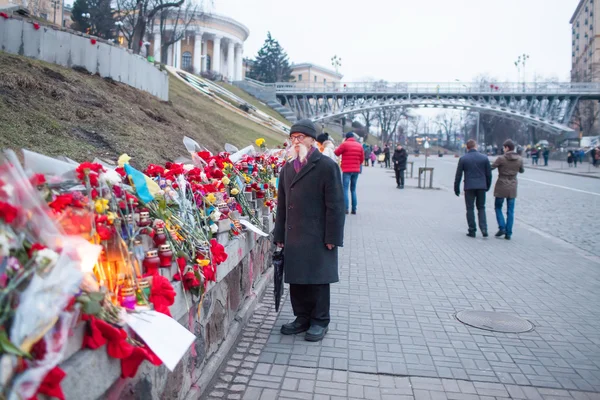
570, 0, 600, 82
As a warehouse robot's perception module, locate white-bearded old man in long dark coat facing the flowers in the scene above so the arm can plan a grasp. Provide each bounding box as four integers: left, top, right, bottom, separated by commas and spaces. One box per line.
274, 120, 345, 341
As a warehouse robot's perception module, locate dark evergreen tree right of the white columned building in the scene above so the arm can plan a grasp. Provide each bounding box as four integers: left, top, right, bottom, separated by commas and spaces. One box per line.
248, 32, 292, 83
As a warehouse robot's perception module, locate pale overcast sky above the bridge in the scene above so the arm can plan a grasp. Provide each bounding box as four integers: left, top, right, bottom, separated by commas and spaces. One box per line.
212, 0, 578, 82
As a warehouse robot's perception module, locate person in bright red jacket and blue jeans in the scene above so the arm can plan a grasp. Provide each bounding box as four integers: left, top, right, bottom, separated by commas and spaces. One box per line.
335, 132, 365, 214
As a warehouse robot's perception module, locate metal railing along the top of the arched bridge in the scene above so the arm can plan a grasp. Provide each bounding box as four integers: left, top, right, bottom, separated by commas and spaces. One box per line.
267, 82, 600, 95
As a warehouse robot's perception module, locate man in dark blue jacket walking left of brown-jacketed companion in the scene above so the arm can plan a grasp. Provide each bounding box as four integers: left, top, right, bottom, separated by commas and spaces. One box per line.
454, 139, 492, 237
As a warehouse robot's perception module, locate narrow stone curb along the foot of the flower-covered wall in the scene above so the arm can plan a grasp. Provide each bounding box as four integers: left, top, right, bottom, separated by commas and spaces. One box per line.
194, 266, 273, 399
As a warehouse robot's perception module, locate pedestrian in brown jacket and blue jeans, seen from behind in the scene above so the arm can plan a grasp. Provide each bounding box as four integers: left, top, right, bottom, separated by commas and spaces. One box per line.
492, 139, 524, 240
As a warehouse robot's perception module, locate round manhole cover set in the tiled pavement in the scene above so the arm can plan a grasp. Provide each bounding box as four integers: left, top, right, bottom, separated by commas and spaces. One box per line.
456, 310, 533, 333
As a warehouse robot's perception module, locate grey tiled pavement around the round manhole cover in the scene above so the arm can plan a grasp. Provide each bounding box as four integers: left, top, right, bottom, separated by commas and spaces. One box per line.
207, 163, 600, 399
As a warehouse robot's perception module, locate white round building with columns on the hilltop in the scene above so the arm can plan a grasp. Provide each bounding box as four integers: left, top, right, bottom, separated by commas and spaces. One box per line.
149, 13, 250, 82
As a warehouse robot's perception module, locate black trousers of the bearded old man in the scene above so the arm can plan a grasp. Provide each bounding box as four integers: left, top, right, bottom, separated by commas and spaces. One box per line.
290, 284, 330, 326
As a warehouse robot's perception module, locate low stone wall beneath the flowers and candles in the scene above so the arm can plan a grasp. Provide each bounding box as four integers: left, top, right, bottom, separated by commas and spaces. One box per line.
61, 224, 272, 400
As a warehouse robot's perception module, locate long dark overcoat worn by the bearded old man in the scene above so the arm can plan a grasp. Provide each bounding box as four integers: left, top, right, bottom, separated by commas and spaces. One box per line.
274, 151, 346, 285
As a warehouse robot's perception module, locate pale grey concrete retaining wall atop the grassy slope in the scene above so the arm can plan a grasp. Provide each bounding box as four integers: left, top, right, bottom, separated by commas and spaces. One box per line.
0, 17, 169, 101
